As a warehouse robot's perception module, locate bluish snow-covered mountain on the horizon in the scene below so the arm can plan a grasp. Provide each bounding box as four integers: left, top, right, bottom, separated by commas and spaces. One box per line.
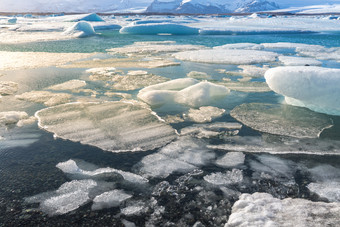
146, 0, 280, 14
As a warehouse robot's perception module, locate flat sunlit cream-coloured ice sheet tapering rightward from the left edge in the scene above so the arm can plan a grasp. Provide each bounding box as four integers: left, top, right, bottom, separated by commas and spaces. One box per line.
0, 51, 94, 70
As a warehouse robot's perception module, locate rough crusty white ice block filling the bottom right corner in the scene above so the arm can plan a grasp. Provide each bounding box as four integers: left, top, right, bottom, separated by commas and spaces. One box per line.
225, 193, 340, 227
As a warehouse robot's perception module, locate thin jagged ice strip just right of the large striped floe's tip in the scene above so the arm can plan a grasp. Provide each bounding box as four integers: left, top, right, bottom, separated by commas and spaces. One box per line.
181, 122, 242, 138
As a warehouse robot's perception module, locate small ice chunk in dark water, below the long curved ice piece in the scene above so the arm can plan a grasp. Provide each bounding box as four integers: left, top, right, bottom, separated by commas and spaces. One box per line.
92, 190, 132, 210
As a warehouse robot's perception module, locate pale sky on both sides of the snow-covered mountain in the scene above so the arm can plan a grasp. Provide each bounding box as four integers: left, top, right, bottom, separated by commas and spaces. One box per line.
0, 0, 340, 12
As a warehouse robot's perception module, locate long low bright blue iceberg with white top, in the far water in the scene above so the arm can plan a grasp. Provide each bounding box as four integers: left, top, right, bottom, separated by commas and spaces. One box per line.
119, 23, 198, 35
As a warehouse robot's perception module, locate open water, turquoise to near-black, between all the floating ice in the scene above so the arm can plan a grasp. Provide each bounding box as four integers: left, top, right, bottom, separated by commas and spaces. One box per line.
0, 27, 340, 226
